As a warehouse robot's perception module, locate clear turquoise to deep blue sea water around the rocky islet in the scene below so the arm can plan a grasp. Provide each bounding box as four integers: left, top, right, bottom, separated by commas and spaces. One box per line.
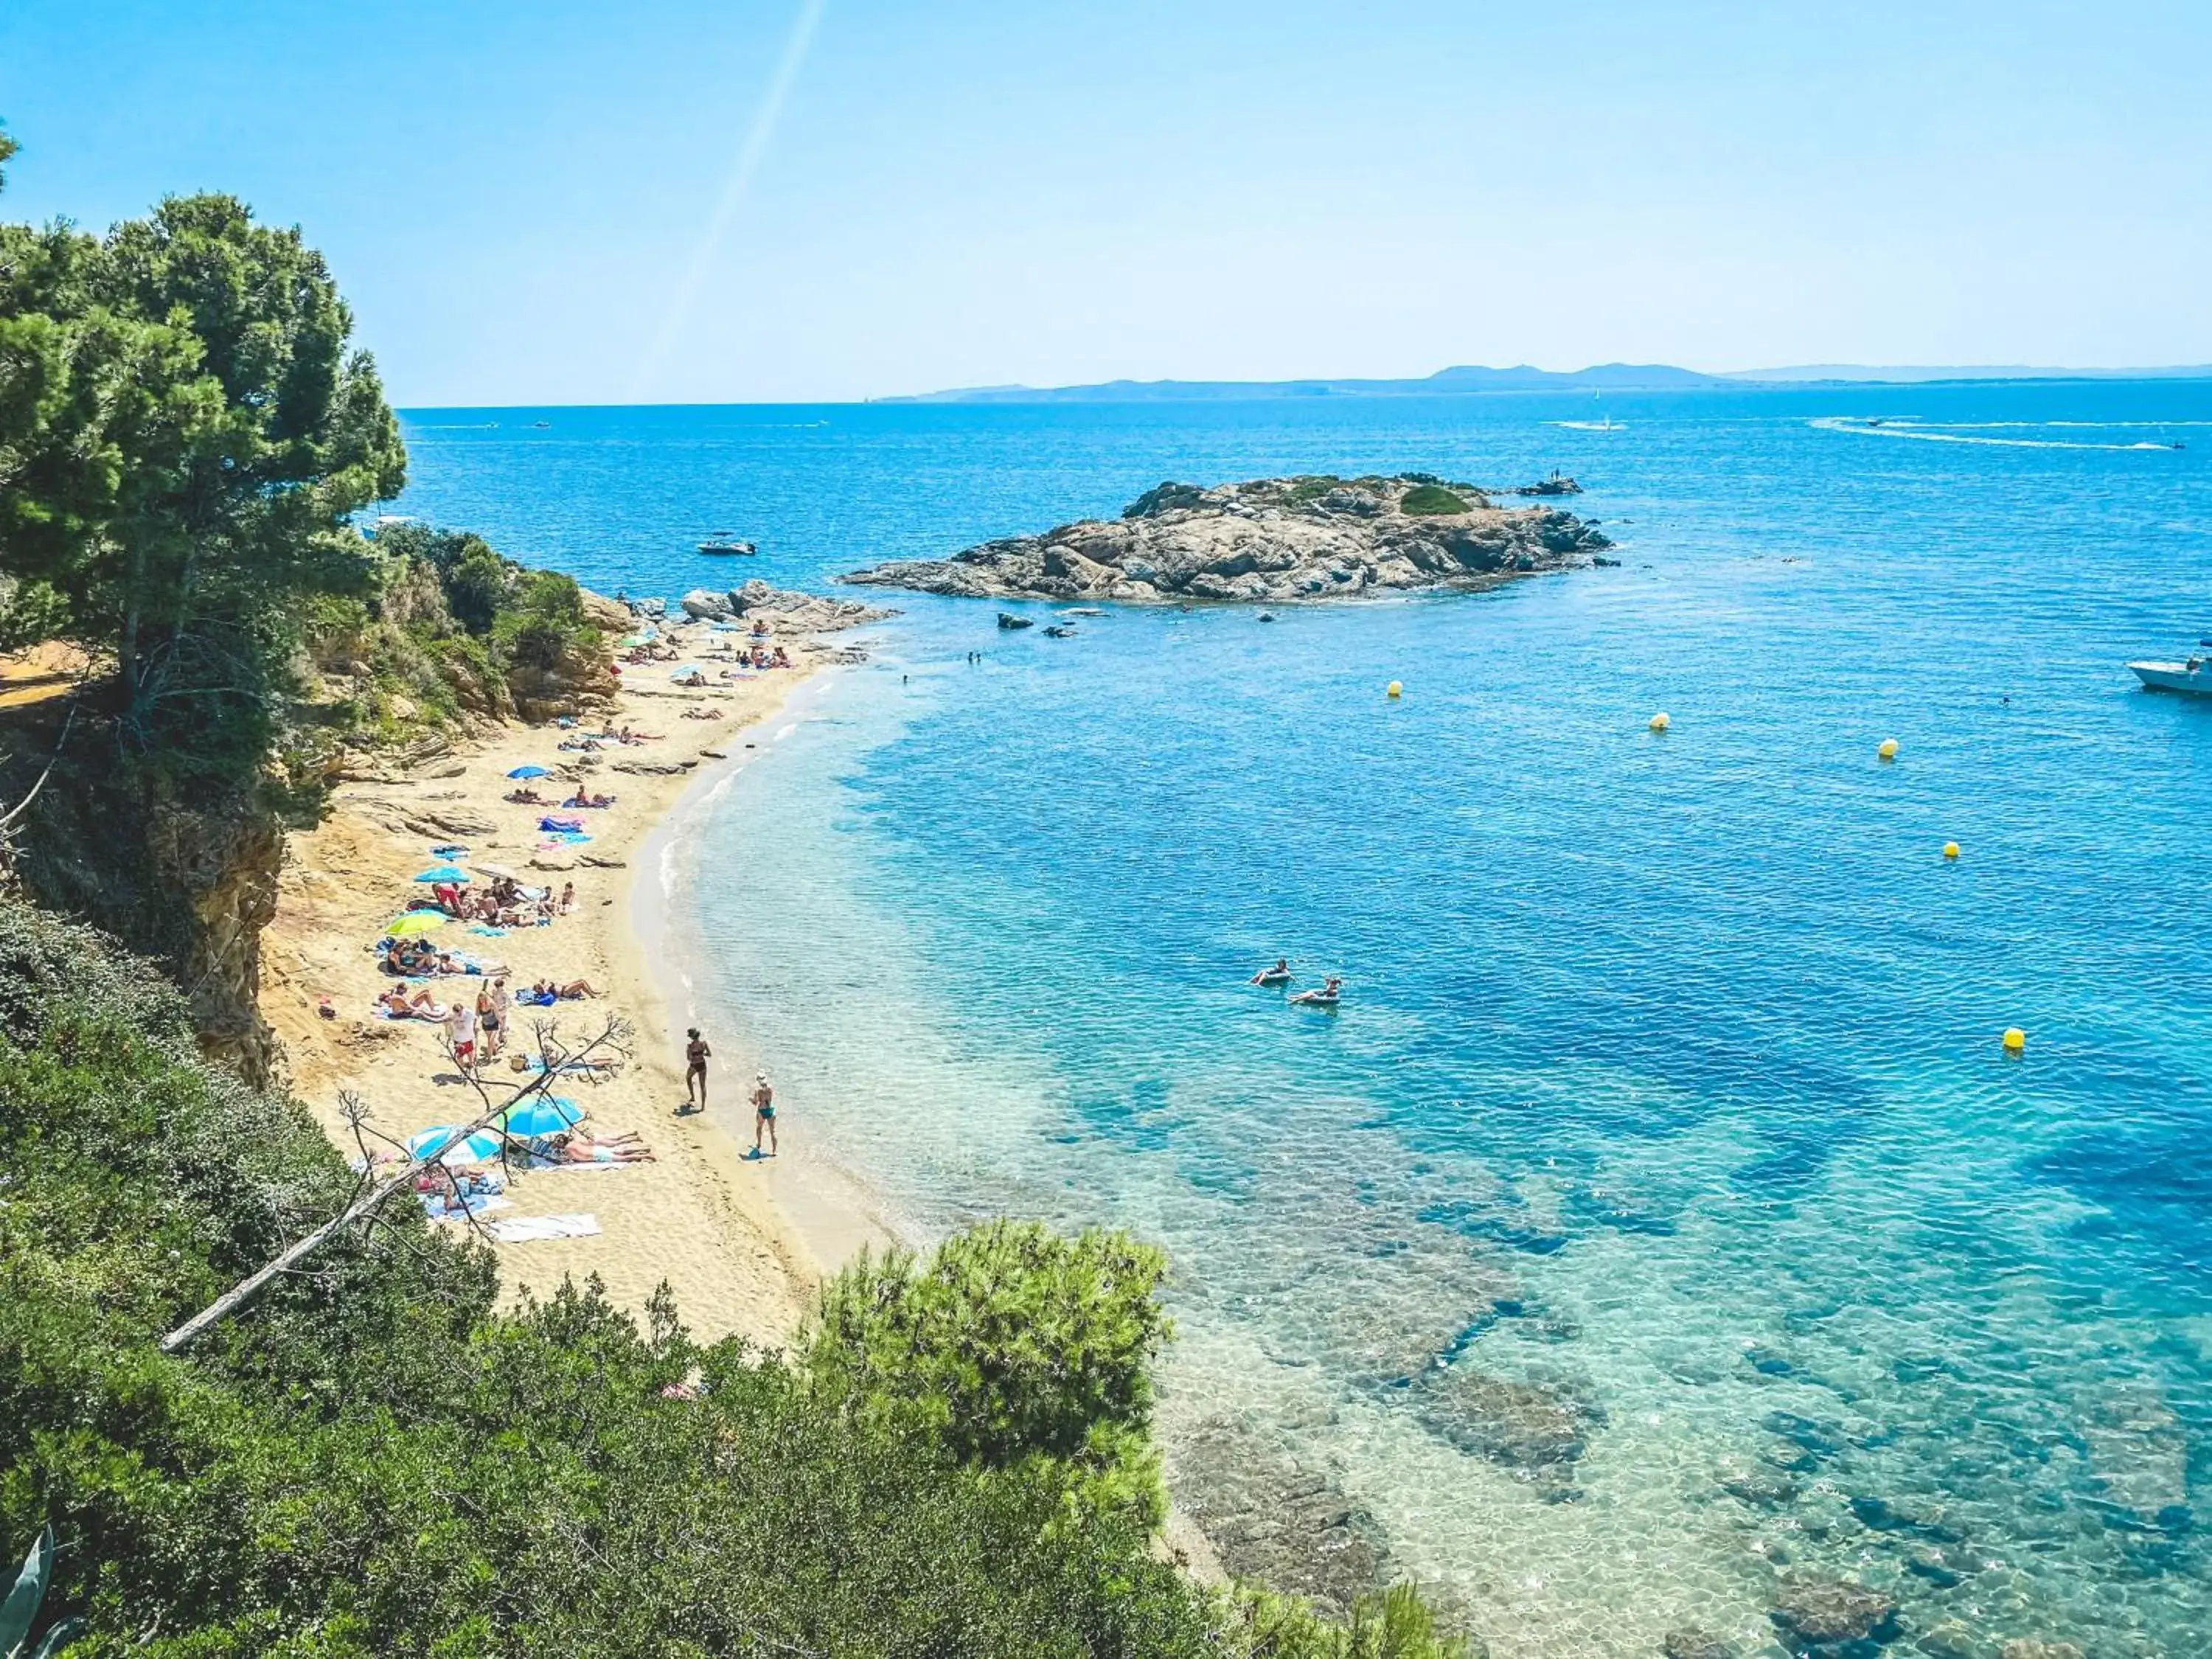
403, 383, 2212, 1659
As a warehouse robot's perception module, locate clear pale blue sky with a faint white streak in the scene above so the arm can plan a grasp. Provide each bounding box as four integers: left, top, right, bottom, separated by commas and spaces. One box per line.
0, 0, 2212, 405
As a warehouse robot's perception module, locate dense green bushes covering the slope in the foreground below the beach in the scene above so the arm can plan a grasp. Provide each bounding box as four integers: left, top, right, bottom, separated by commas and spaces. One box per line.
0, 905, 1460, 1659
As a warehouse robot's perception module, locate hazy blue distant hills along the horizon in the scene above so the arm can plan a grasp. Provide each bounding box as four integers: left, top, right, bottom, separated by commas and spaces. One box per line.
878, 363, 2212, 403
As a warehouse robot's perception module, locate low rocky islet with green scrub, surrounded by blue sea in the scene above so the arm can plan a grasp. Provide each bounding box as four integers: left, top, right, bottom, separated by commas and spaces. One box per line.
843, 473, 1613, 604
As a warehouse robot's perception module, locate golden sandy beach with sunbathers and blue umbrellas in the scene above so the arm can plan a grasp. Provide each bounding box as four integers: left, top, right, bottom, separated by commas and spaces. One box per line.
261, 624, 869, 1343
